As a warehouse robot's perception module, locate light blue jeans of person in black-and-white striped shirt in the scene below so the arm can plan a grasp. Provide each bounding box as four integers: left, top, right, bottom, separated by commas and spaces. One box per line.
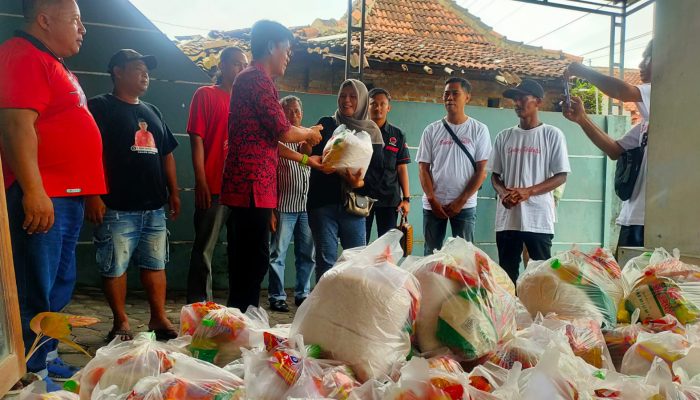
268, 212, 314, 300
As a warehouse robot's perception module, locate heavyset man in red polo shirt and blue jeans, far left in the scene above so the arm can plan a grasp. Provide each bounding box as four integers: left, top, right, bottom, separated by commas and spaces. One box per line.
0, 0, 105, 390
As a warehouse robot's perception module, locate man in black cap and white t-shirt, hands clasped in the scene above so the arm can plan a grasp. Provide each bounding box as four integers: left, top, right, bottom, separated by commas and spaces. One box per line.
489, 79, 571, 282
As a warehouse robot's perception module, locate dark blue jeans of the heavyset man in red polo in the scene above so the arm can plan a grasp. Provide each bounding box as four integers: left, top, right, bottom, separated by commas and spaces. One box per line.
6, 183, 85, 372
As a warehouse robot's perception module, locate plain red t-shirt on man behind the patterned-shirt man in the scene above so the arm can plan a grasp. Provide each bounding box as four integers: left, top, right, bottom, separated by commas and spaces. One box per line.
187, 86, 231, 194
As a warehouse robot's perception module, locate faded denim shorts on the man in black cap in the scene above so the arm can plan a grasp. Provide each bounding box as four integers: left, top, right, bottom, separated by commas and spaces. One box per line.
93, 208, 169, 278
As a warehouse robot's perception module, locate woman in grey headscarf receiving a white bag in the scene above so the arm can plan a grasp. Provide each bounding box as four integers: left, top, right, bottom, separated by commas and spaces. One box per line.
307, 79, 384, 280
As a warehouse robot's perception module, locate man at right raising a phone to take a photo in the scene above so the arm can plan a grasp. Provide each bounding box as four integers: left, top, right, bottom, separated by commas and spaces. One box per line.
563, 42, 652, 253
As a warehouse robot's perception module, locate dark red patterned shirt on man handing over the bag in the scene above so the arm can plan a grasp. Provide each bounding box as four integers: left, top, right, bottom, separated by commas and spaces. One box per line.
221, 64, 291, 208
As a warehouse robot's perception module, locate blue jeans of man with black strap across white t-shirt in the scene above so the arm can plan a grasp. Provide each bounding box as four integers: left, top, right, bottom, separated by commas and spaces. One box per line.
423, 207, 476, 256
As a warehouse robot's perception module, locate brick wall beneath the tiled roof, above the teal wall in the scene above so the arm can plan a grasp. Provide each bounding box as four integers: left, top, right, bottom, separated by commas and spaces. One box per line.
277, 61, 560, 111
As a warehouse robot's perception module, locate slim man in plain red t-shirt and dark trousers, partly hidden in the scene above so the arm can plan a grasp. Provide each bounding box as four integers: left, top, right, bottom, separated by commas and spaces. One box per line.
187, 47, 248, 303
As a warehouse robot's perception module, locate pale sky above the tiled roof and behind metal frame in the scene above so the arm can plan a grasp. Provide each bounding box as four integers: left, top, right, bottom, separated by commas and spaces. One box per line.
130, 0, 654, 67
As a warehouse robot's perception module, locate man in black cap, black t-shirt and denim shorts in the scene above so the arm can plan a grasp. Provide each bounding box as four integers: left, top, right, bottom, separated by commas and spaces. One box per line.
85, 49, 180, 340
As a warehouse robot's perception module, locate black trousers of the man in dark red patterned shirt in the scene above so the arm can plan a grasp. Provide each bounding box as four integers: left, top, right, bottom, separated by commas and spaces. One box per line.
226, 207, 272, 312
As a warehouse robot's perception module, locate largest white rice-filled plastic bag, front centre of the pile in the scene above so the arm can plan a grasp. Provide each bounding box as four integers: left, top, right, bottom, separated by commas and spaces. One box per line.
291, 230, 420, 382
